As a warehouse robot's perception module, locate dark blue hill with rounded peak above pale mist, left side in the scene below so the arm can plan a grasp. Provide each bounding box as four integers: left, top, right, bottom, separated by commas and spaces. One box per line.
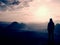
6, 22, 26, 31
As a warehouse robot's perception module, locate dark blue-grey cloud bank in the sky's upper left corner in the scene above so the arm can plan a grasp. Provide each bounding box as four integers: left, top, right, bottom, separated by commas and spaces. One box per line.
0, 0, 32, 11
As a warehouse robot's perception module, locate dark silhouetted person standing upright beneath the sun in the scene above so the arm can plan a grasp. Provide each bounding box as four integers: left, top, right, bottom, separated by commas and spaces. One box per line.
48, 18, 55, 43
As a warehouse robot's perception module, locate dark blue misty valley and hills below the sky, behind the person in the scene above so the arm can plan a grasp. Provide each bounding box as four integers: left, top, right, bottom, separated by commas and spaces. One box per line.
0, 22, 60, 45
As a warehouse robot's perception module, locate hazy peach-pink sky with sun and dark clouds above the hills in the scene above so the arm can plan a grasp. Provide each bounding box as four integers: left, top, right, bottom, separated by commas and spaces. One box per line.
0, 0, 60, 23
